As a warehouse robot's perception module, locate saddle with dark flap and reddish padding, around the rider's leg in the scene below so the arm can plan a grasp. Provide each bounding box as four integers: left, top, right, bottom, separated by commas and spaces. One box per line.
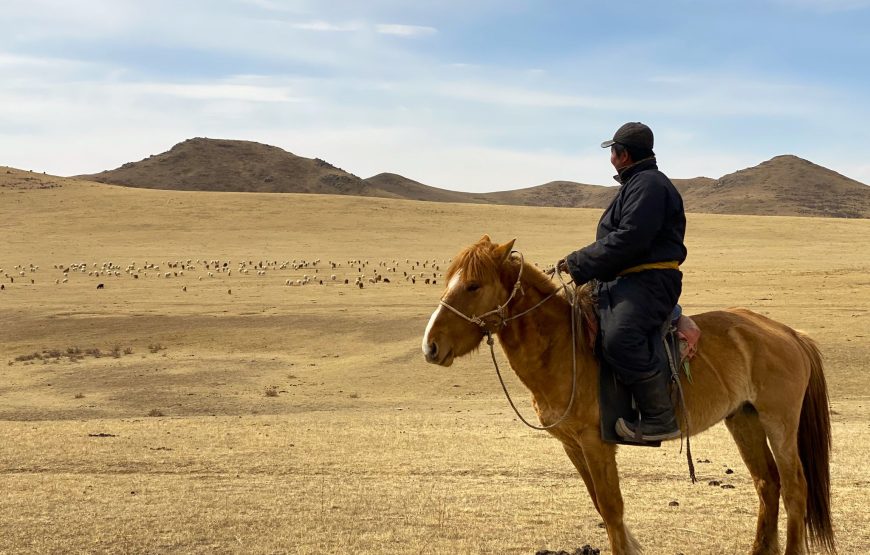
583, 296, 701, 447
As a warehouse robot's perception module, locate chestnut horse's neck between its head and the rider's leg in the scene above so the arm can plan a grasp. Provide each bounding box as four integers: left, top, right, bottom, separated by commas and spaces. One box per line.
498, 276, 589, 404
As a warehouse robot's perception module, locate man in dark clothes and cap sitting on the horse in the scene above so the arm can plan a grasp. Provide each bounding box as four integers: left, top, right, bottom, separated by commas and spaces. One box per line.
559, 122, 686, 442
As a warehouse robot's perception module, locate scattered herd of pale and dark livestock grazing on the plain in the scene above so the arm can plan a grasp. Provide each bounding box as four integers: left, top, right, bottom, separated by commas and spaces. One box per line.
0, 258, 450, 294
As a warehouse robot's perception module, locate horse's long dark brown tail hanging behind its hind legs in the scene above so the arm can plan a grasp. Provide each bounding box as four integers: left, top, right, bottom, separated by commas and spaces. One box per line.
796, 333, 837, 553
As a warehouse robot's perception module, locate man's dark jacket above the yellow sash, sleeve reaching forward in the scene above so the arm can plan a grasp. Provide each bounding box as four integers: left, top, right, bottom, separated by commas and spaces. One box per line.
566, 158, 686, 284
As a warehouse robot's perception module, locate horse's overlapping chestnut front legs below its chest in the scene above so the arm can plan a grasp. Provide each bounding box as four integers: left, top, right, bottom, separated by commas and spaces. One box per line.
566, 429, 642, 555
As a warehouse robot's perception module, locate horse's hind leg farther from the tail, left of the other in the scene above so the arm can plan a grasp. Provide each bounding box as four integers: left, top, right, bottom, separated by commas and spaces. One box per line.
725, 405, 779, 555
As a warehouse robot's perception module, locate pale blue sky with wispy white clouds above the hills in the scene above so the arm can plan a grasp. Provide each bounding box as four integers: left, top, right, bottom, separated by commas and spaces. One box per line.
0, 0, 870, 191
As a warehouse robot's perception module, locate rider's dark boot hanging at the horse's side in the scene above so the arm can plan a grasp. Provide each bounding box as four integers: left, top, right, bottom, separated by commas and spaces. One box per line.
616, 369, 680, 443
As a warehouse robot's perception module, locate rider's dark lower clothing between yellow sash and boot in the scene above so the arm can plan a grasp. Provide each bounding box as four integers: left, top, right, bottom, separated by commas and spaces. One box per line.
598, 270, 683, 386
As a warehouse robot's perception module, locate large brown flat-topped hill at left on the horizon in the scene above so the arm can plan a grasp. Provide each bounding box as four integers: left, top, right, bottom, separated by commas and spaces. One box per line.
79, 138, 395, 197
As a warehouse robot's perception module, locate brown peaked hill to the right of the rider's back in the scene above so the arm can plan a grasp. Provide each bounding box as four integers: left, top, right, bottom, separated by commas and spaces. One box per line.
682, 155, 870, 218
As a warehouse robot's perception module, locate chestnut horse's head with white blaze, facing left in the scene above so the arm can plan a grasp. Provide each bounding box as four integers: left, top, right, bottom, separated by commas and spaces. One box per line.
423, 235, 516, 366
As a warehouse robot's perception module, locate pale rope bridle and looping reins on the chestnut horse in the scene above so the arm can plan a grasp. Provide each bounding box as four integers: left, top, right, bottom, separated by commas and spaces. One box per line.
439, 251, 577, 430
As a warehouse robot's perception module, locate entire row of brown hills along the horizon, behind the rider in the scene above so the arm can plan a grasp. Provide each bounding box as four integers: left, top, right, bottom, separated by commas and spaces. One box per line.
79, 138, 870, 218
